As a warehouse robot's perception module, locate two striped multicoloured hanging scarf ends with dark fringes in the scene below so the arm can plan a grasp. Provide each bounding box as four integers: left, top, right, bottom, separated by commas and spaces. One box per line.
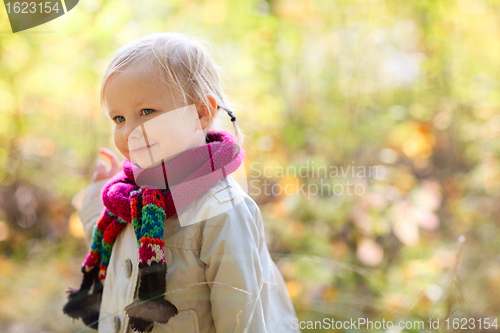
64, 188, 178, 332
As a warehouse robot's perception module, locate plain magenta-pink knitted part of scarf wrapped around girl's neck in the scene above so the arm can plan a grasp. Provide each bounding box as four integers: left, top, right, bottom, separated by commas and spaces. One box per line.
102, 130, 245, 222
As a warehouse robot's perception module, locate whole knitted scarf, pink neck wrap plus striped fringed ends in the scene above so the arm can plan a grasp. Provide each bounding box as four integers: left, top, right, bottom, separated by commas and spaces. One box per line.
63, 131, 244, 332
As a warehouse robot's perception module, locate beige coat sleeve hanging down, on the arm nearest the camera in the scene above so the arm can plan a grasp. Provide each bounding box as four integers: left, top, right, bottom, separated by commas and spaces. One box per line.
200, 201, 268, 333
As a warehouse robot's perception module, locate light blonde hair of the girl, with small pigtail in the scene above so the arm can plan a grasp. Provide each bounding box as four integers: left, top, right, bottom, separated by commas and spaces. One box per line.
100, 32, 244, 145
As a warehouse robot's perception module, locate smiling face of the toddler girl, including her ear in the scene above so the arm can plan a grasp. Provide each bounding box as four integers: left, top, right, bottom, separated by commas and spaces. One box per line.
104, 69, 216, 169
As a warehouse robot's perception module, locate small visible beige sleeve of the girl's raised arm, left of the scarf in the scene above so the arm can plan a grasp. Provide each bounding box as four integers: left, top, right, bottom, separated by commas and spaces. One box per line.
71, 179, 109, 247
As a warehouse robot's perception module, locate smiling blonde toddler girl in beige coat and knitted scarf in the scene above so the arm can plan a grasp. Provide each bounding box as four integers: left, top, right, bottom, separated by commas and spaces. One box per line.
63, 33, 298, 333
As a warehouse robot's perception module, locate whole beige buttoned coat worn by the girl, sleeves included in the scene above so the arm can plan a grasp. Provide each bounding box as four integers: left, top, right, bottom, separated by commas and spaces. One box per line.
73, 176, 300, 333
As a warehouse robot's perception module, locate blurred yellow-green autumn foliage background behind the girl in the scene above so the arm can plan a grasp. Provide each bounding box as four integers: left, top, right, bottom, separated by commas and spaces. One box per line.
0, 0, 500, 333
